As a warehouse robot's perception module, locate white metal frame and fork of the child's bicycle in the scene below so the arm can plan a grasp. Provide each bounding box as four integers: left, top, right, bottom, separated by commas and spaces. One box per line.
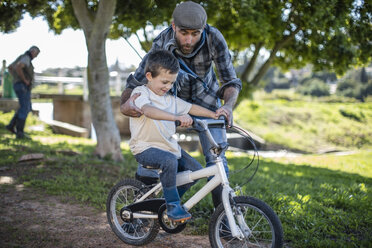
124, 120, 251, 240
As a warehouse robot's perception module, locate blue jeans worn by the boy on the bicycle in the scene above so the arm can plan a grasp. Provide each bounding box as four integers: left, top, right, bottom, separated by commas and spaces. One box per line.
134, 148, 203, 189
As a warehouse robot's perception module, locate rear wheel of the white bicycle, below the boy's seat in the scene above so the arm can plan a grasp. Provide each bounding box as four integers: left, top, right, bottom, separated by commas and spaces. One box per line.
106, 179, 159, 246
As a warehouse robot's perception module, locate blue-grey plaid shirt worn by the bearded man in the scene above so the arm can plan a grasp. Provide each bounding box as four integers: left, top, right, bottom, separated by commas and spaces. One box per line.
126, 25, 242, 111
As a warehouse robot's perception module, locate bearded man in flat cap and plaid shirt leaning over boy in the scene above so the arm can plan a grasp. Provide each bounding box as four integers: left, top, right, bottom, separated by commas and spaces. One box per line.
120, 1, 242, 207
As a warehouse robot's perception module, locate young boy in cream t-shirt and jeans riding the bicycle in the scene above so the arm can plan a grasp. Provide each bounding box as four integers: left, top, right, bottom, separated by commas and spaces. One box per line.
129, 50, 217, 221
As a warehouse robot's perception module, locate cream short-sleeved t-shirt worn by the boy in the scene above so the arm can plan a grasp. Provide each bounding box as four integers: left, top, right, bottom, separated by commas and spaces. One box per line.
129, 85, 191, 158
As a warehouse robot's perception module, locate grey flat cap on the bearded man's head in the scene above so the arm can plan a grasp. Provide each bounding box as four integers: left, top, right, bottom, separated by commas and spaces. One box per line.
172, 1, 207, 29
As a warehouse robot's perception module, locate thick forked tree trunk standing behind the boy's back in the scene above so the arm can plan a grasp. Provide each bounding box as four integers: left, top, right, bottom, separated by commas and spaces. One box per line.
72, 0, 123, 161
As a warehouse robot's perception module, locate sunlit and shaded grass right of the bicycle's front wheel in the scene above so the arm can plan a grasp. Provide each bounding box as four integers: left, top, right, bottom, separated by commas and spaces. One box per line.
229, 151, 372, 247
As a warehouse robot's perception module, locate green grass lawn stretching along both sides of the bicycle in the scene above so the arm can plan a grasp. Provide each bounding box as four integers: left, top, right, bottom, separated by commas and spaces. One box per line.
0, 109, 372, 248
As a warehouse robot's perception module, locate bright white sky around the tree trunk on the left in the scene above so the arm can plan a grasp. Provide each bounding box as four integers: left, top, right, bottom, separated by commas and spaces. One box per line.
0, 14, 145, 72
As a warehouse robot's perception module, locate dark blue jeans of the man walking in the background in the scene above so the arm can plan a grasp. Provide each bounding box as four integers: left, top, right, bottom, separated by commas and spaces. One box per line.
13, 81, 31, 120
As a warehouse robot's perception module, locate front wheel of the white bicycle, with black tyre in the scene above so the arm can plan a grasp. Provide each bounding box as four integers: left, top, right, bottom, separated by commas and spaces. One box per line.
209, 196, 283, 248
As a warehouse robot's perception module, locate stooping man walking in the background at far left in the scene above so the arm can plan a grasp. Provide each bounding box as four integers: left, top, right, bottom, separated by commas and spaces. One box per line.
5, 46, 40, 139
